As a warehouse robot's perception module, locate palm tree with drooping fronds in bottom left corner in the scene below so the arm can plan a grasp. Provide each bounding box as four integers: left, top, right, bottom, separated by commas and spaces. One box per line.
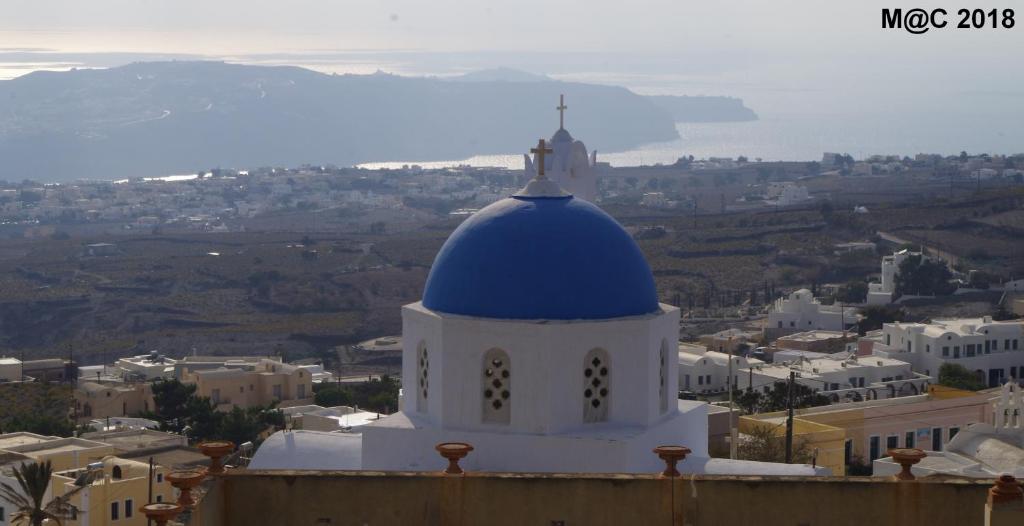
0, 461, 86, 526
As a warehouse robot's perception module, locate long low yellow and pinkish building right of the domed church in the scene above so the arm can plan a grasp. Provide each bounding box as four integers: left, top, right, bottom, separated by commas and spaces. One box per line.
738, 386, 991, 476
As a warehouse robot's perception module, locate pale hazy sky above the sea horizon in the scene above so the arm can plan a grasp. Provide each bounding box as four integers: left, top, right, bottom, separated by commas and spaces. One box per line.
0, 0, 1024, 57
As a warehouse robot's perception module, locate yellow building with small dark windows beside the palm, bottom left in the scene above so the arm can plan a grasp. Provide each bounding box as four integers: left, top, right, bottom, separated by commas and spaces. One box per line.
52, 456, 176, 526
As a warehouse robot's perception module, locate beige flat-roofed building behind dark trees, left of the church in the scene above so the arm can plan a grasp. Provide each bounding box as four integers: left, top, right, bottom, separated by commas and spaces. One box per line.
181, 358, 313, 410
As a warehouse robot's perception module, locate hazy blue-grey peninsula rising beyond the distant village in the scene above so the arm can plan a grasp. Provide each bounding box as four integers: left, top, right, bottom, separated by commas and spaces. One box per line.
0, 61, 757, 182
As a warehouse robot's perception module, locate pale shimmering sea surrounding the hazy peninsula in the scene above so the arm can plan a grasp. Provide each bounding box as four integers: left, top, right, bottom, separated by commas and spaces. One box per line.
6, 36, 1024, 171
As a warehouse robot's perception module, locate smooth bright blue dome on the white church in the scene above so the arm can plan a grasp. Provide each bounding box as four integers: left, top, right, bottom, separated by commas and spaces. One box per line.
423, 196, 658, 319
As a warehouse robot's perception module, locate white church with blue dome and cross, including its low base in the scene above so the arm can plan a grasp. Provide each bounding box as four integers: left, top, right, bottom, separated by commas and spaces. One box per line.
249, 118, 822, 475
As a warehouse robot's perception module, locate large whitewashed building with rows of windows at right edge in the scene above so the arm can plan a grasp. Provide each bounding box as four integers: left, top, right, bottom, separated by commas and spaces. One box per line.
869, 316, 1024, 387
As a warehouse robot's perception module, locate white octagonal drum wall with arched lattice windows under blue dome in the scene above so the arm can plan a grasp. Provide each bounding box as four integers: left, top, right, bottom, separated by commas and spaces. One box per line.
403, 304, 679, 433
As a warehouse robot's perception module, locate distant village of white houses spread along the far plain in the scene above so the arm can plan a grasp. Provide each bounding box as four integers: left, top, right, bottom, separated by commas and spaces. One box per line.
0, 152, 1024, 235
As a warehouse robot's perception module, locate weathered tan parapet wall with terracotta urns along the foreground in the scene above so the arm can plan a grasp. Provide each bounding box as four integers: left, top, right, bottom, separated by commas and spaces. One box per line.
194, 470, 992, 526
